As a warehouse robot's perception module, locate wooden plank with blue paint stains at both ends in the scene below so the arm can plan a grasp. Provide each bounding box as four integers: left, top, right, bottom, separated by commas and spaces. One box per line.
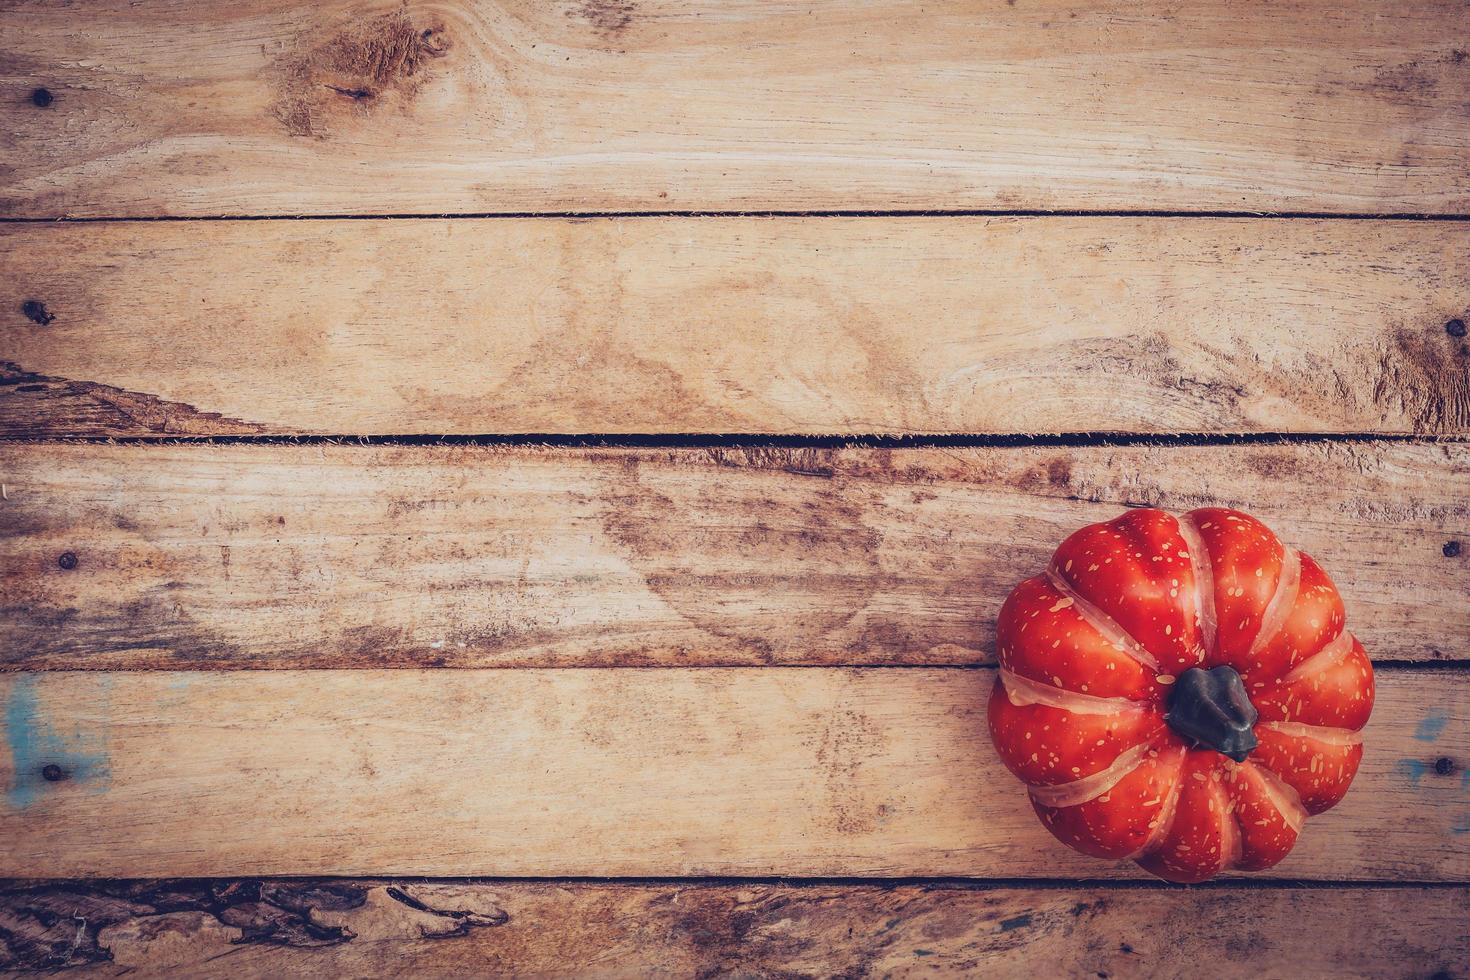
0, 667, 1470, 882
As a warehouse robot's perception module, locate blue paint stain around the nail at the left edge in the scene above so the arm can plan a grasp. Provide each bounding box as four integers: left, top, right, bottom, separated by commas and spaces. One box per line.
4, 674, 112, 810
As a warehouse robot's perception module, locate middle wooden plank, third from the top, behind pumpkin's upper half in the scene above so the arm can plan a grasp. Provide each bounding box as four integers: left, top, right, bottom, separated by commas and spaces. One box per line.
0, 442, 1470, 670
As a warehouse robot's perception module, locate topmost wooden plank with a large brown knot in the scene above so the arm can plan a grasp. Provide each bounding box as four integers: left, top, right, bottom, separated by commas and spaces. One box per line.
0, 0, 1470, 217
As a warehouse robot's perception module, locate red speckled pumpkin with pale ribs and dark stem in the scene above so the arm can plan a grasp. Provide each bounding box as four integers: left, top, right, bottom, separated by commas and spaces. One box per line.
989, 507, 1373, 882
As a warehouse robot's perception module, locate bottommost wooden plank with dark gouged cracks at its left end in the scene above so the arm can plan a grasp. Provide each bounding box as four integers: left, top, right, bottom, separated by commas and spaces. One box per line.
0, 879, 1470, 980
